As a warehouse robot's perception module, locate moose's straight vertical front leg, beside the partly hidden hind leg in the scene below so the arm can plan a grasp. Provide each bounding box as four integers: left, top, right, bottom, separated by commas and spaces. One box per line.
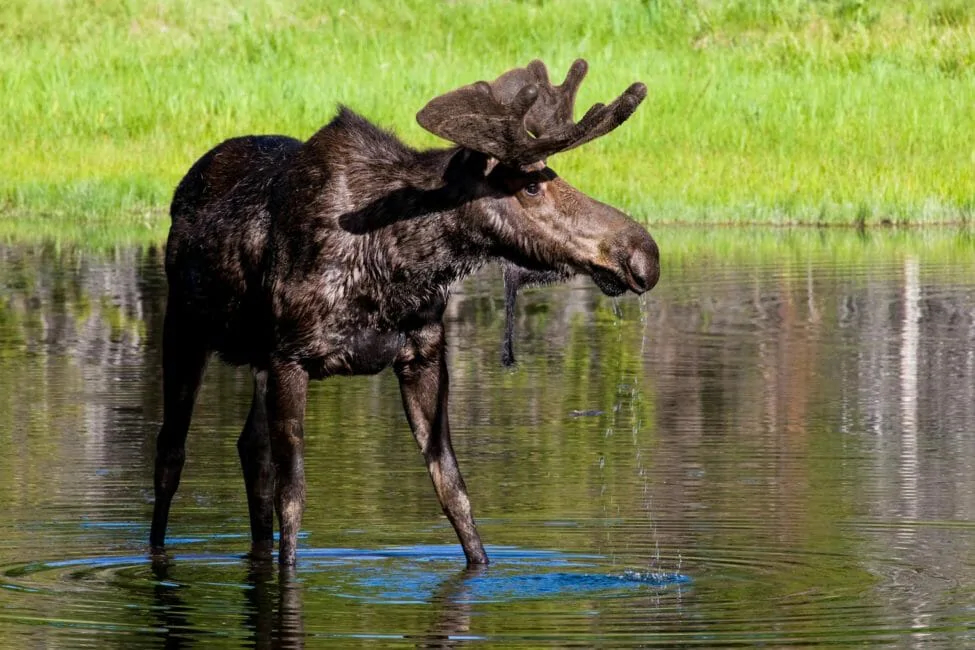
267, 362, 308, 565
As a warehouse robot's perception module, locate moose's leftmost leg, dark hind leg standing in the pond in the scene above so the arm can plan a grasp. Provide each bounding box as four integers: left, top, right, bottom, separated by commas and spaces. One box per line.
149, 301, 207, 551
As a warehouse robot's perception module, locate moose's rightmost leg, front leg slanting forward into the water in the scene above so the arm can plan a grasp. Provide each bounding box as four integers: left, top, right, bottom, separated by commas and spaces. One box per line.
395, 323, 488, 565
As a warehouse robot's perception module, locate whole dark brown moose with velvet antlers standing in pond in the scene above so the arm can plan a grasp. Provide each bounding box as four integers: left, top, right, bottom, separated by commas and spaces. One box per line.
149, 59, 659, 566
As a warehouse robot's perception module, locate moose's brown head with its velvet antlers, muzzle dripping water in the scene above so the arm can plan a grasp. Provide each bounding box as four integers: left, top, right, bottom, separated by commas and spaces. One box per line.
417, 59, 660, 296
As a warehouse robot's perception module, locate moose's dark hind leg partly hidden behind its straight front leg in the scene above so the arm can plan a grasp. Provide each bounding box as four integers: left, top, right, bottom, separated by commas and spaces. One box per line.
237, 370, 274, 557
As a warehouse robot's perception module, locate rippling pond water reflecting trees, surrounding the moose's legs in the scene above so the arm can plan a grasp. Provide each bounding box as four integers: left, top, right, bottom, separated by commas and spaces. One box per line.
0, 231, 975, 648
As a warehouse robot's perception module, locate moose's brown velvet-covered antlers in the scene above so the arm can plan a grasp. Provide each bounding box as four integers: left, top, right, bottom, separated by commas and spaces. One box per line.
416, 59, 647, 166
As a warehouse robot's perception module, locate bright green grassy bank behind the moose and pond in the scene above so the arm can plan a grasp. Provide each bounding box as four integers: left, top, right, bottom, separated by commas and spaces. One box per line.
0, 0, 975, 240
